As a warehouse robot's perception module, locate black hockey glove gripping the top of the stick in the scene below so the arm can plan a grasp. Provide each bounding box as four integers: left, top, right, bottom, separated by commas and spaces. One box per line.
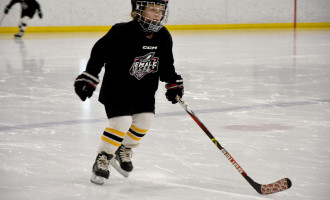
165, 75, 184, 104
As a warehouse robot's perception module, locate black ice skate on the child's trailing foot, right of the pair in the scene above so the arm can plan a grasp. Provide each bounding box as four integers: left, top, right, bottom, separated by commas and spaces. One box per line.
110, 145, 133, 177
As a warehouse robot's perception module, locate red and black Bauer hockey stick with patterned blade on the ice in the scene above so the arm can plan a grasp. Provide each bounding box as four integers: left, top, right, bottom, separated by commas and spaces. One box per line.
176, 96, 292, 194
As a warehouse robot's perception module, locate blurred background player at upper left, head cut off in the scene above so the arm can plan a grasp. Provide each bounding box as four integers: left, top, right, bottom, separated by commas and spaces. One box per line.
4, 0, 42, 37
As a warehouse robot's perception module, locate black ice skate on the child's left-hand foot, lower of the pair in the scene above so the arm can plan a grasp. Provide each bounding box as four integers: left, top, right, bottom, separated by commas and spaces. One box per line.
90, 152, 113, 185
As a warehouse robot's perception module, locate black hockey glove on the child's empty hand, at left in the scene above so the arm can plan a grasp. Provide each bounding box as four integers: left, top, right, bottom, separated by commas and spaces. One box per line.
74, 72, 100, 101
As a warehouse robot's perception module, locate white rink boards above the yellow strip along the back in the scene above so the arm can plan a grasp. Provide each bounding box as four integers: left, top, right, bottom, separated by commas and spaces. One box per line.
0, 0, 330, 27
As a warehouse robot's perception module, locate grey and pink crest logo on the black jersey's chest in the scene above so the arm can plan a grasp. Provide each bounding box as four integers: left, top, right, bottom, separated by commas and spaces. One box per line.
129, 52, 159, 80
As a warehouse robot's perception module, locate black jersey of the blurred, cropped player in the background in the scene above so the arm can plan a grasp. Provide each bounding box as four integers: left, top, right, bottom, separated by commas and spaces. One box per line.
7, 0, 41, 18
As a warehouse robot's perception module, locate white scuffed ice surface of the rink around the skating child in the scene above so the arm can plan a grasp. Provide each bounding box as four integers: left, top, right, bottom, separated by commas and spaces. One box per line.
0, 29, 330, 200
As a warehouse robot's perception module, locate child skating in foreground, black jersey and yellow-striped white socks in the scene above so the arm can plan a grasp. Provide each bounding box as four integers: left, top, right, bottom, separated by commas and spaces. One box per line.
74, 0, 183, 184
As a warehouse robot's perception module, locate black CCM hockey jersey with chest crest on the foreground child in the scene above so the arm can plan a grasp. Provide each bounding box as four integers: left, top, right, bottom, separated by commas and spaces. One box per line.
86, 21, 177, 113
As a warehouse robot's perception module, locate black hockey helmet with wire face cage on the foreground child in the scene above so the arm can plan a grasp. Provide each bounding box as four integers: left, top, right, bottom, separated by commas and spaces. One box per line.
131, 0, 168, 35
